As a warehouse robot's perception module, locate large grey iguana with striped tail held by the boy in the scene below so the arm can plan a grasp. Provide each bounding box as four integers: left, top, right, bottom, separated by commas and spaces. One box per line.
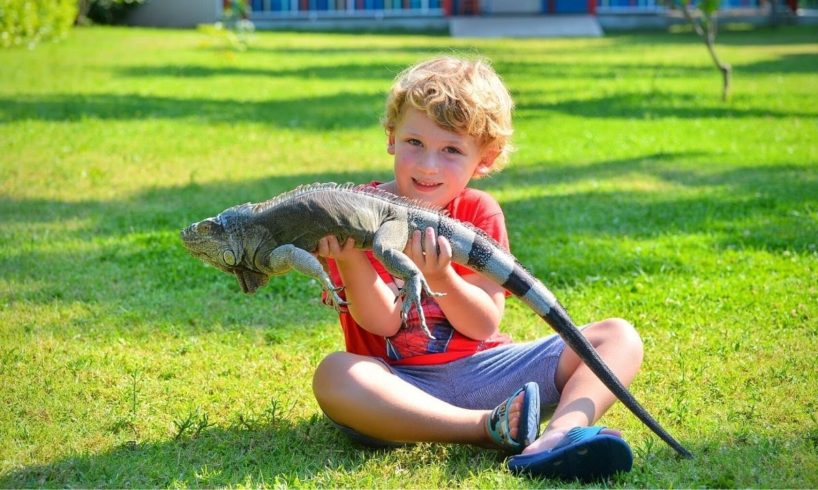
181, 183, 692, 458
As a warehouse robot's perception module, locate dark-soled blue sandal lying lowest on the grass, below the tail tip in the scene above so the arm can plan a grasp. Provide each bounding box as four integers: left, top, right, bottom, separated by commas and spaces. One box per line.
508, 427, 633, 481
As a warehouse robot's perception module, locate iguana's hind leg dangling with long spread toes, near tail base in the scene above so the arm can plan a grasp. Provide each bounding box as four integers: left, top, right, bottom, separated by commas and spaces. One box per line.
372, 221, 443, 339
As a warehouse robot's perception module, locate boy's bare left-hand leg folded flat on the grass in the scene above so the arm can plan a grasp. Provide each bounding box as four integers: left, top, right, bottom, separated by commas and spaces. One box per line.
313, 352, 522, 445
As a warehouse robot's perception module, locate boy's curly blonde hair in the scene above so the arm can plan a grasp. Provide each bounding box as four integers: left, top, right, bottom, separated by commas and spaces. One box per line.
382, 56, 514, 171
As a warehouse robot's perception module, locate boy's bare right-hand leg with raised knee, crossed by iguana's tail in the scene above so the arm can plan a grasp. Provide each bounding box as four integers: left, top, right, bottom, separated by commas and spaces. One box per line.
523, 318, 643, 454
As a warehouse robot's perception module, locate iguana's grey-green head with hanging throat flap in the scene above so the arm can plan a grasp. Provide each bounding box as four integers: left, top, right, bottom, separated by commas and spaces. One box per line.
181, 210, 270, 293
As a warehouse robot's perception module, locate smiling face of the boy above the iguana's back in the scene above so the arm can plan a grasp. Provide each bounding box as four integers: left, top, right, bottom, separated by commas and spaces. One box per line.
388, 108, 494, 207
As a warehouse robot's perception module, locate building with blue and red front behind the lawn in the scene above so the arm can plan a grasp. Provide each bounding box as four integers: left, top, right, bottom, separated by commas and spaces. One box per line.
128, 0, 800, 33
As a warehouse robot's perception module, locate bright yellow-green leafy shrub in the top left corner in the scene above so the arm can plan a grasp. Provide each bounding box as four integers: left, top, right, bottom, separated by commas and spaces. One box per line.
0, 0, 77, 47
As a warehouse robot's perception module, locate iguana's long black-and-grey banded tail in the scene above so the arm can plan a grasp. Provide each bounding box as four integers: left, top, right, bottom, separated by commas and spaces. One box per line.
465, 230, 693, 458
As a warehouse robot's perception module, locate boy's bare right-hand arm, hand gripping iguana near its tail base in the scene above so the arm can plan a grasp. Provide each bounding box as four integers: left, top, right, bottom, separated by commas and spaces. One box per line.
404, 228, 505, 340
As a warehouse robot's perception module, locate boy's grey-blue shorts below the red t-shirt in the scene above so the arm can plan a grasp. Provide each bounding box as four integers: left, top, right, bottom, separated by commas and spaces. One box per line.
330, 335, 565, 446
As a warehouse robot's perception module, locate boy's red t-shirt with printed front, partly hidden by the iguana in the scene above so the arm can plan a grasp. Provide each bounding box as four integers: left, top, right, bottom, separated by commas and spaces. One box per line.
325, 182, 511, 365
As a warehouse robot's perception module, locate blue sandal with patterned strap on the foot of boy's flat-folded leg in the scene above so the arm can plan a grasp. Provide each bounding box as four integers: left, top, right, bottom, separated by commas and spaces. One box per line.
486, 381, 540, 454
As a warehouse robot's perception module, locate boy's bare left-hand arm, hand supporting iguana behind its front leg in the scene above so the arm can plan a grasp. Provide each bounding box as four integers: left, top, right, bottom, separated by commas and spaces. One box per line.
317, 236, 401, 337
